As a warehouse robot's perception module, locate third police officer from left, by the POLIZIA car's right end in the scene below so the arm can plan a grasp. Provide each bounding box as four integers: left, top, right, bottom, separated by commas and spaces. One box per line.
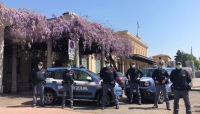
100, 61, 119, 110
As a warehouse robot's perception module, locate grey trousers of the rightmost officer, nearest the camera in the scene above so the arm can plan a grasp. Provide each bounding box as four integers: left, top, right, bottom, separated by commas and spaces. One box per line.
173, 89, 192, 114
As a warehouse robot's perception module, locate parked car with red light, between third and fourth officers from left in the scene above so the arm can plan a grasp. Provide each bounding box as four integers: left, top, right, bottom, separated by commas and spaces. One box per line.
115, 72, 128, 89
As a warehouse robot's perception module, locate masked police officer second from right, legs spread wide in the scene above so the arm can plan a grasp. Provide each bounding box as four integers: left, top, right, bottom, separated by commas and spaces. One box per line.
152, 61, 171, 110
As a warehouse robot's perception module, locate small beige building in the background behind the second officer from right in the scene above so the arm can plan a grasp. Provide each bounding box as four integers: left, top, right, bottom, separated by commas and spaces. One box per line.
153, 54, 171, 66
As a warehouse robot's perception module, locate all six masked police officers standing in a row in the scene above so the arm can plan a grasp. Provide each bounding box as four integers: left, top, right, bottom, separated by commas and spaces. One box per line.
32, 61, 191, 114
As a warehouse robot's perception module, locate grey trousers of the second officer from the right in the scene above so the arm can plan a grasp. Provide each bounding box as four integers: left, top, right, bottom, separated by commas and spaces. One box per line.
154, 84, 170, 108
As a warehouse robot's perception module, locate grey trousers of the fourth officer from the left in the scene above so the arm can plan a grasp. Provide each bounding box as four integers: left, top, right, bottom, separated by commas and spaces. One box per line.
130, 82, 141, 102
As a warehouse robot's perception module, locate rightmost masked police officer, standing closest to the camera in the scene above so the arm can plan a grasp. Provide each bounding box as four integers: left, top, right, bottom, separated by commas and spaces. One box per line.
170, 61, 192, 114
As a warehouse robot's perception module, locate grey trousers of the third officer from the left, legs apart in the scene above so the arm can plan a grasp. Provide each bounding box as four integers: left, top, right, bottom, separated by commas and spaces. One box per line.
102, 84, 119, 107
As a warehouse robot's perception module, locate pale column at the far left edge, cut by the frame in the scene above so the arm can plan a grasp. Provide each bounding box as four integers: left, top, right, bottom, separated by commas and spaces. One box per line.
0, 27, 4, 93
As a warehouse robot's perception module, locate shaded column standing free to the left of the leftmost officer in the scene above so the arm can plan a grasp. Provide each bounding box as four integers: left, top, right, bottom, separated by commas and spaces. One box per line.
11, 44, 17, 93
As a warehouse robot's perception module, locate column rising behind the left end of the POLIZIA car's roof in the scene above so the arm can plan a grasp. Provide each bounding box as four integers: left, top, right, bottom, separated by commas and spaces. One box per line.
47, 39, 52, 68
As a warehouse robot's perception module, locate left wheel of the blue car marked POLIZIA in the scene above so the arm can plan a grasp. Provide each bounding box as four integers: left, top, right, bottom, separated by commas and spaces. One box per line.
44, 91, 56, 105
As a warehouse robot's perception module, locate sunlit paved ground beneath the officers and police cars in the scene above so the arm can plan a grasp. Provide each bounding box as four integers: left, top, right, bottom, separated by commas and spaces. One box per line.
0, 91, 200, 114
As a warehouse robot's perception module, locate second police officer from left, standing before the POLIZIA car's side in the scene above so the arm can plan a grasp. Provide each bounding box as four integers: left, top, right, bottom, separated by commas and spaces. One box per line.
62, 64, 74, 108
